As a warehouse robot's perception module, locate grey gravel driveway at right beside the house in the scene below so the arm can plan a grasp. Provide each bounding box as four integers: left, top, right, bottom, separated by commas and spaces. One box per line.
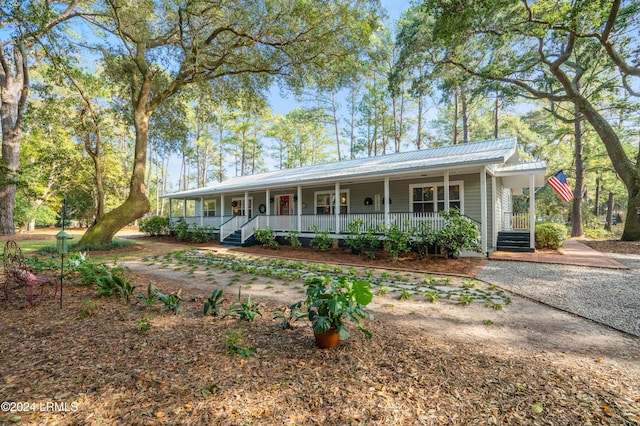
477, 253, 640, 336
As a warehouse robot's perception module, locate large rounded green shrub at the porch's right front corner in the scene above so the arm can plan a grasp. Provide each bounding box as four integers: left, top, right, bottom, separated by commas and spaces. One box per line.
435, 209, 482, 258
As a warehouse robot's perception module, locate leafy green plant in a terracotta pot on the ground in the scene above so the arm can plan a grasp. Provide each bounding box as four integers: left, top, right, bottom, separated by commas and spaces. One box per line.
304, 276, 373, 349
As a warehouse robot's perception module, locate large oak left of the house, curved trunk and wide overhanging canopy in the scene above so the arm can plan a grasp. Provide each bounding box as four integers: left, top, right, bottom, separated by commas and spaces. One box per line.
79, 0, 379, 245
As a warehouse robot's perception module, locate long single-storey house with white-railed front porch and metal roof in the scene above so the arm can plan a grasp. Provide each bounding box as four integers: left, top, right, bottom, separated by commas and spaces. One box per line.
164, 138, 546, 252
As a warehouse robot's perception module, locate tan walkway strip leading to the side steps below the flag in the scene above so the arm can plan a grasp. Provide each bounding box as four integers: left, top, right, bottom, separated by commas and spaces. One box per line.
489, 239, 629, 269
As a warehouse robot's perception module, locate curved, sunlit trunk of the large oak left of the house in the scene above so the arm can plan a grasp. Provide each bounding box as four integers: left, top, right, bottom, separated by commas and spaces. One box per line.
78, 87, 151, 247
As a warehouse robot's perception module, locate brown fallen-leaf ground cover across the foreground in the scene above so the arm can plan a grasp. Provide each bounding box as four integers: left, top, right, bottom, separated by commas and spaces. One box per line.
0, 276, 640, 425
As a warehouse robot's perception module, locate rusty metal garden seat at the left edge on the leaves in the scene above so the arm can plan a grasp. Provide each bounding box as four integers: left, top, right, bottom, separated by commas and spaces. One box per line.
2, 240, 58, 306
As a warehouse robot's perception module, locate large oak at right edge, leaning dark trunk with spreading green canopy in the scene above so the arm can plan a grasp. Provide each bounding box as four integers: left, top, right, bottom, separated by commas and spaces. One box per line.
398, 0, 640, 240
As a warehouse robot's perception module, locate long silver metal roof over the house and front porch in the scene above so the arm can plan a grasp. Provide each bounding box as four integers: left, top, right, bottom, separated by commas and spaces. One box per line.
162, 137, 517, 198
